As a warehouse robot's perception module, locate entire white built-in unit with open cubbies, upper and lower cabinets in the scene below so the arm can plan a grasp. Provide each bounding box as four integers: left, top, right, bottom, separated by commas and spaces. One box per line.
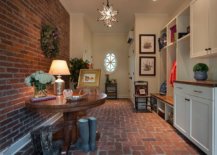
160, 0, 217, 155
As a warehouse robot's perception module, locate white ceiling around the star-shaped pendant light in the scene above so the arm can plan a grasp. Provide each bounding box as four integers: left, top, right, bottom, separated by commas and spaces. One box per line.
60, 0, 190, 33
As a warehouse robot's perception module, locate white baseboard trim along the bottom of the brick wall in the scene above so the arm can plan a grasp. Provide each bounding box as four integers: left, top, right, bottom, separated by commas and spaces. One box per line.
0, 113, 62, 155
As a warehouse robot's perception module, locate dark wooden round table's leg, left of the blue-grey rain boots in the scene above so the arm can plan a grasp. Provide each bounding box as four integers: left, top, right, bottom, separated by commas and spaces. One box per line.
62, 112, 77, 154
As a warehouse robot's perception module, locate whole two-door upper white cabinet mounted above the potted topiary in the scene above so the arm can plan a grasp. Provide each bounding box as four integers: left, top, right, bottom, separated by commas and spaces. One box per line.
190, 0, 217, 58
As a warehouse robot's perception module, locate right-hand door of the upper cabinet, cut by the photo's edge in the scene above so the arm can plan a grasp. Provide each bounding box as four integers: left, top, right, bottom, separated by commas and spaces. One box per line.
209, 0, 217, 54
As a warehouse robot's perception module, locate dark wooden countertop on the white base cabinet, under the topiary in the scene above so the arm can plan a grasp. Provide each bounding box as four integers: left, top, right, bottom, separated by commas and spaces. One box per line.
175, 81, 217, 87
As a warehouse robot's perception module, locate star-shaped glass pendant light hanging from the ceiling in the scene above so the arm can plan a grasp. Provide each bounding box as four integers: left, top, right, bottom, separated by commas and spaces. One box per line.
97, 0, 118, 27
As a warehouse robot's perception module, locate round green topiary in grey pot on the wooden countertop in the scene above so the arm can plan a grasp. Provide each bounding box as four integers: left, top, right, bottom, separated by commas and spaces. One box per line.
193, 63, 209, 81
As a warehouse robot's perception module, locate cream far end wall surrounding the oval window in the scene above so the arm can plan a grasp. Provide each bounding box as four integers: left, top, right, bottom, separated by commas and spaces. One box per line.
92, 34, 129, 98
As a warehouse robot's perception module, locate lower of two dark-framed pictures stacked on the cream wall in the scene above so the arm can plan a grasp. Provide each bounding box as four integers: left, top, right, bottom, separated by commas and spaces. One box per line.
139, 56, 156, 76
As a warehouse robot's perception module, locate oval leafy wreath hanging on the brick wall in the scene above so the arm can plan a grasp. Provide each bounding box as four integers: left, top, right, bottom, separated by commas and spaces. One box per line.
41, 25, 59, 58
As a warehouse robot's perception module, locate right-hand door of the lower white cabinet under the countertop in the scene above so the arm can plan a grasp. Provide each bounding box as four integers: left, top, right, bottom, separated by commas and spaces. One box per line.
190, 96, 212, 154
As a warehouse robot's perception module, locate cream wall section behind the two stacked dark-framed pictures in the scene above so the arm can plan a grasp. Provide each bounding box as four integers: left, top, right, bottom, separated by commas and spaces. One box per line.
135, 14, 168, 93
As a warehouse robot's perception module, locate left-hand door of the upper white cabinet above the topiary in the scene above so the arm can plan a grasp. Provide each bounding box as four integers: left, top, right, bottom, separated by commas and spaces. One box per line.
190, 0, 209, 57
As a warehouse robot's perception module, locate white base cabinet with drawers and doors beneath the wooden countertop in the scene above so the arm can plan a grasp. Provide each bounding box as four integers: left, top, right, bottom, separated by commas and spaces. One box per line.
174, 81, 217, 155
